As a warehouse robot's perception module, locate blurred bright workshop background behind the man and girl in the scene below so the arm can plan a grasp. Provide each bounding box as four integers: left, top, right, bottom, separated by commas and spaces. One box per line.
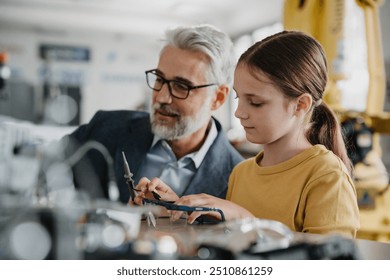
0, 0, 390, 259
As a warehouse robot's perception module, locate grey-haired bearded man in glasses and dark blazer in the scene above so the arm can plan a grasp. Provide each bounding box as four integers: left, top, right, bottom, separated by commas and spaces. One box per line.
70, 25, 243, 203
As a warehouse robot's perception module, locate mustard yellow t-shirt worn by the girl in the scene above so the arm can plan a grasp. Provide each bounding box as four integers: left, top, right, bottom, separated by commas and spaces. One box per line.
226, 145, 359, 237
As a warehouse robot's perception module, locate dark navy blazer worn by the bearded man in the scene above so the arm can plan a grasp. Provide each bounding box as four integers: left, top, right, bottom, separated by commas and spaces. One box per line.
67, 110, 243, 203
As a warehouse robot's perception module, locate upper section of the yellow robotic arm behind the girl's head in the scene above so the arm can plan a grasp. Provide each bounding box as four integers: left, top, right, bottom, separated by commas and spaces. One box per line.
284, 0, 390, 116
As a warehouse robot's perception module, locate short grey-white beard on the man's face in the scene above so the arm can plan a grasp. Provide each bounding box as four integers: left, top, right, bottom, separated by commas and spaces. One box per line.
150, 97, 211, 140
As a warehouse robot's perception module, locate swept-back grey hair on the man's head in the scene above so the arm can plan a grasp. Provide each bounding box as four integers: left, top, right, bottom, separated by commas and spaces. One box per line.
161, 24, 236, 90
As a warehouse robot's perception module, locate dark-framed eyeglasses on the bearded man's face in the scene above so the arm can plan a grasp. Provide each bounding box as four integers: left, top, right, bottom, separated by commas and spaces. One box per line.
145, 69, 216, 99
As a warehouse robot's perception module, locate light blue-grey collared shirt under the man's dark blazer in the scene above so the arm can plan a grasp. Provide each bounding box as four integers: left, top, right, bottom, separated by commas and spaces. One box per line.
135, 119, 218, 196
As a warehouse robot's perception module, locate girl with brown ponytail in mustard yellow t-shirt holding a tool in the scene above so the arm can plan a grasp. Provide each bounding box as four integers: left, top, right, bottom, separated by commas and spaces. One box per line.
137, 31, 359, 237
